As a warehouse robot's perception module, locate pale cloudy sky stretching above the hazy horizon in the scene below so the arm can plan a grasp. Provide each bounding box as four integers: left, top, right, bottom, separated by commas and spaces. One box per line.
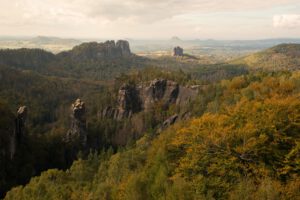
0, 0, 300, 39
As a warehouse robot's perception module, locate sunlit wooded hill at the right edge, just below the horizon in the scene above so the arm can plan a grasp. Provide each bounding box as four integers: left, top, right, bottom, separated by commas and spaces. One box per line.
232, 44, 300, 71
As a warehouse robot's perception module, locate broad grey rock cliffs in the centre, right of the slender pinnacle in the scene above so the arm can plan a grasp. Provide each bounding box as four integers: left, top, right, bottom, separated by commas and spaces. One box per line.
101, 79, 197, 120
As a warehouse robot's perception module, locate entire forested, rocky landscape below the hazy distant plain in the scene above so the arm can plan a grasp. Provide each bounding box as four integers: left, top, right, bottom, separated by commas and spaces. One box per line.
0, 41, 300, 199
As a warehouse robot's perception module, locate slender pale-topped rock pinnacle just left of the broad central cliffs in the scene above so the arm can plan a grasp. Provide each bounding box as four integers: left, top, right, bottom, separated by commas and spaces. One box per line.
64, 99, 87, 147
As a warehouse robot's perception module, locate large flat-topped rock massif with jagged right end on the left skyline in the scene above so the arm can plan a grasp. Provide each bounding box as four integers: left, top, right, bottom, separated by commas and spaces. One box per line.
69, 40, 132, 61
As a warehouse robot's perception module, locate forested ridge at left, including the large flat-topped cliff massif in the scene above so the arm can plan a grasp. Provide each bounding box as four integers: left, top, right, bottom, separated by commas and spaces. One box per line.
0, 40, 146, 80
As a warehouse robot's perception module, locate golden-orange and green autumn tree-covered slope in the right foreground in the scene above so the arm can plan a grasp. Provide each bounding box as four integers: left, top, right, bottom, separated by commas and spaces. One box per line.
5, 72, 300, 200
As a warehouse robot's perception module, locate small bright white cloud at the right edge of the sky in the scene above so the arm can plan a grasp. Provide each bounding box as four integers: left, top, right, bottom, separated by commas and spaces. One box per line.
273, 14, 300, 28
